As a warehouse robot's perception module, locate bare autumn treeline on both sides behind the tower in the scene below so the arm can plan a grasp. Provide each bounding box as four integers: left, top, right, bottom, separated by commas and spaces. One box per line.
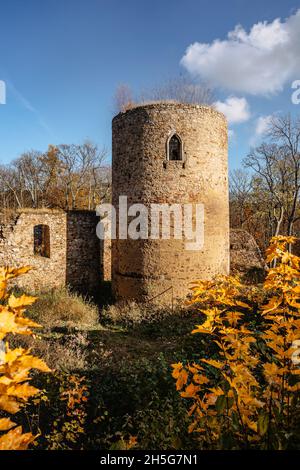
0, 110, 300, 250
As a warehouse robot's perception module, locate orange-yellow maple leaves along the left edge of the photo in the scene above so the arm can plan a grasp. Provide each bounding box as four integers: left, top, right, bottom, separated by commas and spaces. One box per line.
0, 266, 50, 450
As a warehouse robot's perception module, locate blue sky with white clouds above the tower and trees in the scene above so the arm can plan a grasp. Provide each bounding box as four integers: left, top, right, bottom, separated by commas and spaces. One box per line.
0, 0, 300, 168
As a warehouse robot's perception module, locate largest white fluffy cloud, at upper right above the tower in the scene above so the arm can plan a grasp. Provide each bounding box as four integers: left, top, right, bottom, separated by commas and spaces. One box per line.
181, 10, 300, 95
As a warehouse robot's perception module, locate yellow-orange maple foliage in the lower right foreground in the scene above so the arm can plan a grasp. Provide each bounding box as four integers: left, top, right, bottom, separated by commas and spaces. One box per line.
172, 236, 300, 449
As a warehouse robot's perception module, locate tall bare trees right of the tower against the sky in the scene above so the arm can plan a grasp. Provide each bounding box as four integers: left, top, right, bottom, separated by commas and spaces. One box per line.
230, 115, 300, 250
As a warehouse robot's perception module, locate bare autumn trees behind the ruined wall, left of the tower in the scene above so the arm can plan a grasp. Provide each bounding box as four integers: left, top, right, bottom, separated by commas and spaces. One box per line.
0, 142, 111, 210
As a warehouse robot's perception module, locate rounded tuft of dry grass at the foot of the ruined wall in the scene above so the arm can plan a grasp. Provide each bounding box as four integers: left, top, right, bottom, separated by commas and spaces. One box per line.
28, 288, 99, 329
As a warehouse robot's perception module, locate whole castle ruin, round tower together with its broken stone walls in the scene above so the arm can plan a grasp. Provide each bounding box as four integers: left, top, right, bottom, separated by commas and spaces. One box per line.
0, 102, 263, 304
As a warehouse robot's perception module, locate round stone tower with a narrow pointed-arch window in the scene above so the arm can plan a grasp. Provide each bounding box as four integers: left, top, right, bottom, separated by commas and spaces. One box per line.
112, 102, 229, 304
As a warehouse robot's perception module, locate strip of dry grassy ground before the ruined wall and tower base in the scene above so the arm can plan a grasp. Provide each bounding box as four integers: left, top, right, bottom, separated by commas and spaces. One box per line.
10, 289, 196, 373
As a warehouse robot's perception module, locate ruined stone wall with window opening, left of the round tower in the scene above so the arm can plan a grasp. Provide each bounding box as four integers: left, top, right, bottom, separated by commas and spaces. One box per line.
0, 209, 101, 294
